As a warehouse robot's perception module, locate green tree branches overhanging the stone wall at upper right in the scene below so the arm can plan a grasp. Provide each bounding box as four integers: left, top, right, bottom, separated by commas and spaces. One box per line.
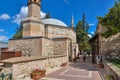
97, 1, 120, 38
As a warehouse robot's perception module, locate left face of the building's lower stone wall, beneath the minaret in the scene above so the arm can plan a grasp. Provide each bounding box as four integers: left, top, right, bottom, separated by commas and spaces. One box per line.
9, 38, 42, 56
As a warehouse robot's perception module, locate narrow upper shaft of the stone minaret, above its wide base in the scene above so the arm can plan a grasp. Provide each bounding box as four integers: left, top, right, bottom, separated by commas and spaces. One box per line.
27, 0, 41, 19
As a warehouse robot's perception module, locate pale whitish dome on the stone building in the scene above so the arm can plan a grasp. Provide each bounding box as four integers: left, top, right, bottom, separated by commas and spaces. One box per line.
42, 18, 67, 27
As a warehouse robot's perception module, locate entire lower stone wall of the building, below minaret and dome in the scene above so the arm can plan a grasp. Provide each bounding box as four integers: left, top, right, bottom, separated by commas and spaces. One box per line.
9, 37, 76, 56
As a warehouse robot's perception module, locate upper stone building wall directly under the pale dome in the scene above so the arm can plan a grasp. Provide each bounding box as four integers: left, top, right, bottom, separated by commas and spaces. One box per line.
45, 25, 76, 42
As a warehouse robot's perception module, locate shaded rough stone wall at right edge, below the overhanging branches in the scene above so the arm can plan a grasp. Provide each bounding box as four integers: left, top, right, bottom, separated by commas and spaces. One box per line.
102, 33, 120, 57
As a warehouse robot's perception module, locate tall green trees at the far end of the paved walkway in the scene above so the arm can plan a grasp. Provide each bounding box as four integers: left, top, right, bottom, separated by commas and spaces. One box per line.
75, 15, 91, 51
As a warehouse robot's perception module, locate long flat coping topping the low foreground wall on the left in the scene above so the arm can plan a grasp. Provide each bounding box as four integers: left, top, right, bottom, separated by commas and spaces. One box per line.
0, 55, 67, 64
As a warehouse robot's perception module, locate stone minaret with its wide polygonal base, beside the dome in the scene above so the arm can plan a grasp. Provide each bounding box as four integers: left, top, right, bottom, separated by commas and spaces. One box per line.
22, 0, 44, 37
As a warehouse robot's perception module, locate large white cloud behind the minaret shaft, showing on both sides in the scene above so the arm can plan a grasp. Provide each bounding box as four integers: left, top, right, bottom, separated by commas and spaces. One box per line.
13, 6, 46, 24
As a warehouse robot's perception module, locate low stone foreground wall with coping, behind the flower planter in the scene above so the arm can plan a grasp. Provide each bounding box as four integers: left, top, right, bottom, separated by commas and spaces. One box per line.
2, 55, 68, 80
